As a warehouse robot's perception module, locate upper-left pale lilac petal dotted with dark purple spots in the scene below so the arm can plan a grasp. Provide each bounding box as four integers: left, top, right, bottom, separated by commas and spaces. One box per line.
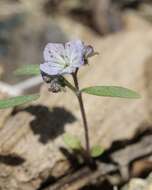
43, 43, 65, 64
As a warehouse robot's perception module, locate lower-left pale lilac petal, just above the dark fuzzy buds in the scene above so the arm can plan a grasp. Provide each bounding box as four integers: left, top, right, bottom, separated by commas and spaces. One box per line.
40, 62, 63, 76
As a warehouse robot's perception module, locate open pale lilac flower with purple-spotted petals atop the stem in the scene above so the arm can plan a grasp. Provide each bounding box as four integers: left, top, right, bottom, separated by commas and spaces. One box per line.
40, 40, 86, 76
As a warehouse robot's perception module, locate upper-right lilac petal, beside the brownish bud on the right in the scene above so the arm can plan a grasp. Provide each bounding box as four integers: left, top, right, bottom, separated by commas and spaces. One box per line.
65, 40, 85, 67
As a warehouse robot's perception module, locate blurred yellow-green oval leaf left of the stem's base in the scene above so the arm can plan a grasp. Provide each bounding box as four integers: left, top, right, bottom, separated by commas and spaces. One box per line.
63, 133, 82, 150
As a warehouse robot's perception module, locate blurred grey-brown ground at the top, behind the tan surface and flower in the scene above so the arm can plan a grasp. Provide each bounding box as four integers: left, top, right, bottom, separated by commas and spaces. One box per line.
0, 0, 152, 89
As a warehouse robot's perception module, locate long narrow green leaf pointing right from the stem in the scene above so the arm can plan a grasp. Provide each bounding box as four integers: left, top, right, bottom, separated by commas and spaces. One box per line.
81, 86, 140, 99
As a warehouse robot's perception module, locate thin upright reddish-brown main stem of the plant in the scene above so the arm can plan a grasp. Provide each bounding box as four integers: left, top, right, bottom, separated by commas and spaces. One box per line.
72, 72, 90, 159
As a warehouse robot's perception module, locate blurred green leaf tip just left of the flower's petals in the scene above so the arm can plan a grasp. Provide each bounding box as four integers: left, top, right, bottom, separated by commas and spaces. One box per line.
14, 64, 40, 75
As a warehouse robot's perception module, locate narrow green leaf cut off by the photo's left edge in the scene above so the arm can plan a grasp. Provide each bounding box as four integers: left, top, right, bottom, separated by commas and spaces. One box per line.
0, 94, 40, 109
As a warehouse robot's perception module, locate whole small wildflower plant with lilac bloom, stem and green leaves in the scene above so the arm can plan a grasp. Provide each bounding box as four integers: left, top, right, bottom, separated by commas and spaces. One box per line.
0, 40, 140, 160
